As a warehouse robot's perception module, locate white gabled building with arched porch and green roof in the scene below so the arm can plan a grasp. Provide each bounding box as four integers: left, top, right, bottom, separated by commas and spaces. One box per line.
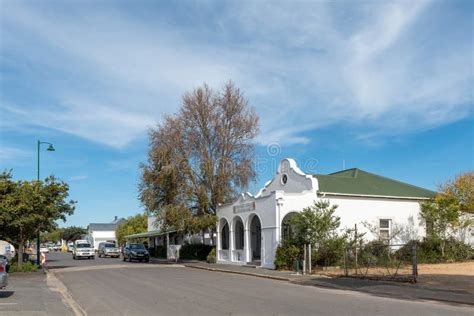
217, 159, 435, 269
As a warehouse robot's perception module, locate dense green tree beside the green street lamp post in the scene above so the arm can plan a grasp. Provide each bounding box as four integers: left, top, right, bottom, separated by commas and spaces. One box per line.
0, 172, 75, 265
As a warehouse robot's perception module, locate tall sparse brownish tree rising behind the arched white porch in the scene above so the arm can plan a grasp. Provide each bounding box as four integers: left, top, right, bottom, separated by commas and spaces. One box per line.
139, 82, 258, 232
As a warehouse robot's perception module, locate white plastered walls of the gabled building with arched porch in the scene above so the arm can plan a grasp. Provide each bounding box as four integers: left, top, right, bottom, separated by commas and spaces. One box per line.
217, 159, 425, 268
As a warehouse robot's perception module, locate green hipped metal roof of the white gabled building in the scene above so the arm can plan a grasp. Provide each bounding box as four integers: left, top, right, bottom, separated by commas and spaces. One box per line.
314, 168, 436, 199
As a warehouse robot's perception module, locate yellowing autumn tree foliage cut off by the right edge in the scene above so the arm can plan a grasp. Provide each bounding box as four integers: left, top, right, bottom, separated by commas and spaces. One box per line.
441, 171, 474, 214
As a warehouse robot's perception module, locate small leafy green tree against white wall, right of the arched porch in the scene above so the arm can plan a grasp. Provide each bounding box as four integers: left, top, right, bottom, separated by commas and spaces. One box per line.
290, 201, 341, 246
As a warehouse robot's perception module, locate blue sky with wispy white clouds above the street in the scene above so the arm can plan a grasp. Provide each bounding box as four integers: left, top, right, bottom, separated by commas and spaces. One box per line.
0, 0, 474, 226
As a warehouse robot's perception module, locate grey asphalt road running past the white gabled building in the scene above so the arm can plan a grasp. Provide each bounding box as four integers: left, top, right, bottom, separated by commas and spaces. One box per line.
45, 254, 474, 316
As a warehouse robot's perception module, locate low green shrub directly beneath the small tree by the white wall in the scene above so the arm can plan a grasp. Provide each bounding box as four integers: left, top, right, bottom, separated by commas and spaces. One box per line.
311, 237, 346, 267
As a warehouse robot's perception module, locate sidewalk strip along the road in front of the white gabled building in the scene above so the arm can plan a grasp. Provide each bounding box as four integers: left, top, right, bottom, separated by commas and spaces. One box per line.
182, 262, 474, 305
